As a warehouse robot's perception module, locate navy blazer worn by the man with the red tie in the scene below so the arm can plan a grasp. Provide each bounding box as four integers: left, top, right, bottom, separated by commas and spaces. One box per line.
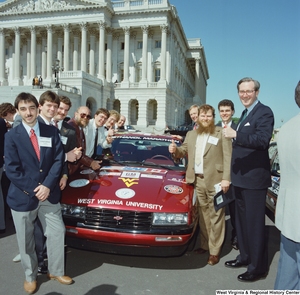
4, 123, 64, 211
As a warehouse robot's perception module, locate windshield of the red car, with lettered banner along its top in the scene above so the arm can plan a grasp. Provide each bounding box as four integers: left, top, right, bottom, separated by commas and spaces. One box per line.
98, 134, 185, 169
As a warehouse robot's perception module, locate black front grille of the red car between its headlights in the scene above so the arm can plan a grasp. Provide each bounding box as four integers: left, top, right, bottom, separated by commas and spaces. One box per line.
85, 207, 152, 230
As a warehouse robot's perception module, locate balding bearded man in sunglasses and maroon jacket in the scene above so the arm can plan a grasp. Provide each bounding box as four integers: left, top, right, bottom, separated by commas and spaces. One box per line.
68, 106, 101, 175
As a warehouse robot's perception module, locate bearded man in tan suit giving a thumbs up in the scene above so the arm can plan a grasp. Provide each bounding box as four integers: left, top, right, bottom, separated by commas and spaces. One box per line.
169, 104, 232, 265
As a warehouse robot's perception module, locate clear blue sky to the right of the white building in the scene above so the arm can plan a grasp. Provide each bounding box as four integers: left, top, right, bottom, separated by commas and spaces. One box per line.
169, 0, 300, 127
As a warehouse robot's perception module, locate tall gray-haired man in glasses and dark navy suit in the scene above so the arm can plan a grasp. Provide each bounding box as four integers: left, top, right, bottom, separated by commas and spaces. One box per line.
223, 78, 274, 282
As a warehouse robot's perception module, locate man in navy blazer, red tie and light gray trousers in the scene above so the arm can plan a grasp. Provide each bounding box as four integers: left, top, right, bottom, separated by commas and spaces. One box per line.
4, 92, 73, 294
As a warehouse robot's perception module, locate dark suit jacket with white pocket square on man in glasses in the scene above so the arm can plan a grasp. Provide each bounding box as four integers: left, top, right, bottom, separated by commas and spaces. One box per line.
231, 102, 274, 189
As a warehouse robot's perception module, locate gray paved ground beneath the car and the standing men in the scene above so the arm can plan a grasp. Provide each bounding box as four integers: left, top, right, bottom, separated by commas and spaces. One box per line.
0, 209, 279, 295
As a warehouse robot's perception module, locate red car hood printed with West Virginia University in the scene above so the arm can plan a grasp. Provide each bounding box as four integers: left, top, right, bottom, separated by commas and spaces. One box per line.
61, 166, 196, 212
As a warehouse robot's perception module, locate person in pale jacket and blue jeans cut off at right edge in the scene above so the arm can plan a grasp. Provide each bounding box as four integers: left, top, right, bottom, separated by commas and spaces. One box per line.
274, 81, 300, 290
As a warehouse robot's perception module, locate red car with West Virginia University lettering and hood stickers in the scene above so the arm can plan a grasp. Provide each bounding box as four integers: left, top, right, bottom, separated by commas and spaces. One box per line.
61, 133, 198, 256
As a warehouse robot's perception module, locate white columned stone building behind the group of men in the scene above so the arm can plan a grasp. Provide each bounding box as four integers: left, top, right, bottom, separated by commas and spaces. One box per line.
0, 0, 209, 130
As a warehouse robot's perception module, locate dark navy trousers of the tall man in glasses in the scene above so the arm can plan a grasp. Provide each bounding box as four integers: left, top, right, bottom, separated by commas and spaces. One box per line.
233, 186, 268, 274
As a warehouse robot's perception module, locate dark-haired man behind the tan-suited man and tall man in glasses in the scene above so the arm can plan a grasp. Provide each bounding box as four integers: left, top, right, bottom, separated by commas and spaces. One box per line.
216, 99, 239, 250
